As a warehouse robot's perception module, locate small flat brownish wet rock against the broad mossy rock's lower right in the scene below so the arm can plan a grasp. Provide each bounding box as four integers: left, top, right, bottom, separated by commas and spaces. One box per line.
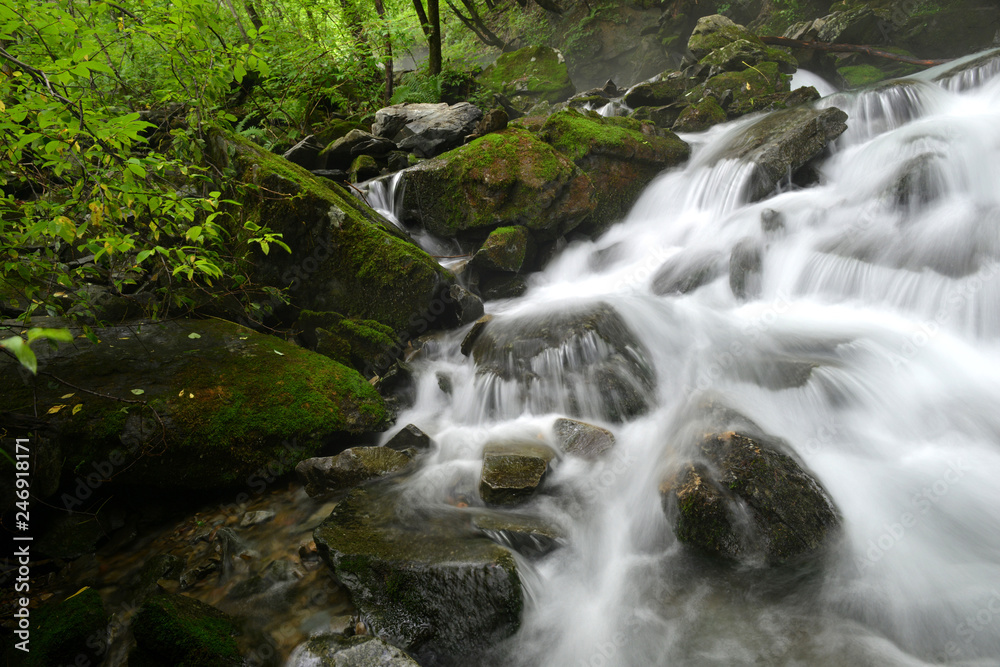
295, 447, 412, 496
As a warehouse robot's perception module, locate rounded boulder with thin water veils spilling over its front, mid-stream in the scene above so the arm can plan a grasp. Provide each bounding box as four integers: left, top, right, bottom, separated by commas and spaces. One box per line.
462, 303, 656, 421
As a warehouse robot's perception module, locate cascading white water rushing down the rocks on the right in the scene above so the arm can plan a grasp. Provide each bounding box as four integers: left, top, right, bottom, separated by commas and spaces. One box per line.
386, 54, 1000, 667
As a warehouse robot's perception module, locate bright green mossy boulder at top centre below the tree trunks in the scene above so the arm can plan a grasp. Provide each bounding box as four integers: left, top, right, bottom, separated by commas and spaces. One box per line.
478, 46, 576, 103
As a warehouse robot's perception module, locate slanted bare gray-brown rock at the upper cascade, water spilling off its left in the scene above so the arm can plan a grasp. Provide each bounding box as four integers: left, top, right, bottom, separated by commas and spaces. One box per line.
720, 107, 847, 201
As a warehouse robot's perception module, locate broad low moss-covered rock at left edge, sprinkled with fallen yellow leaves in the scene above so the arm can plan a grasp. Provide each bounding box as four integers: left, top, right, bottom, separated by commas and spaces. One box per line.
0, 319, 388, 494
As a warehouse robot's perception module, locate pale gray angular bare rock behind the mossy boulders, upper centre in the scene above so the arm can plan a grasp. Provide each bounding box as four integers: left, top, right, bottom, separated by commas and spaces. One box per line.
372, 102, 483, 158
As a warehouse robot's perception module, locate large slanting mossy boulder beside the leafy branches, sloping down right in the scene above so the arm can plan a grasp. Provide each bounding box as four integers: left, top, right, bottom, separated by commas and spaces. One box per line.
226, 130, 454, 332
